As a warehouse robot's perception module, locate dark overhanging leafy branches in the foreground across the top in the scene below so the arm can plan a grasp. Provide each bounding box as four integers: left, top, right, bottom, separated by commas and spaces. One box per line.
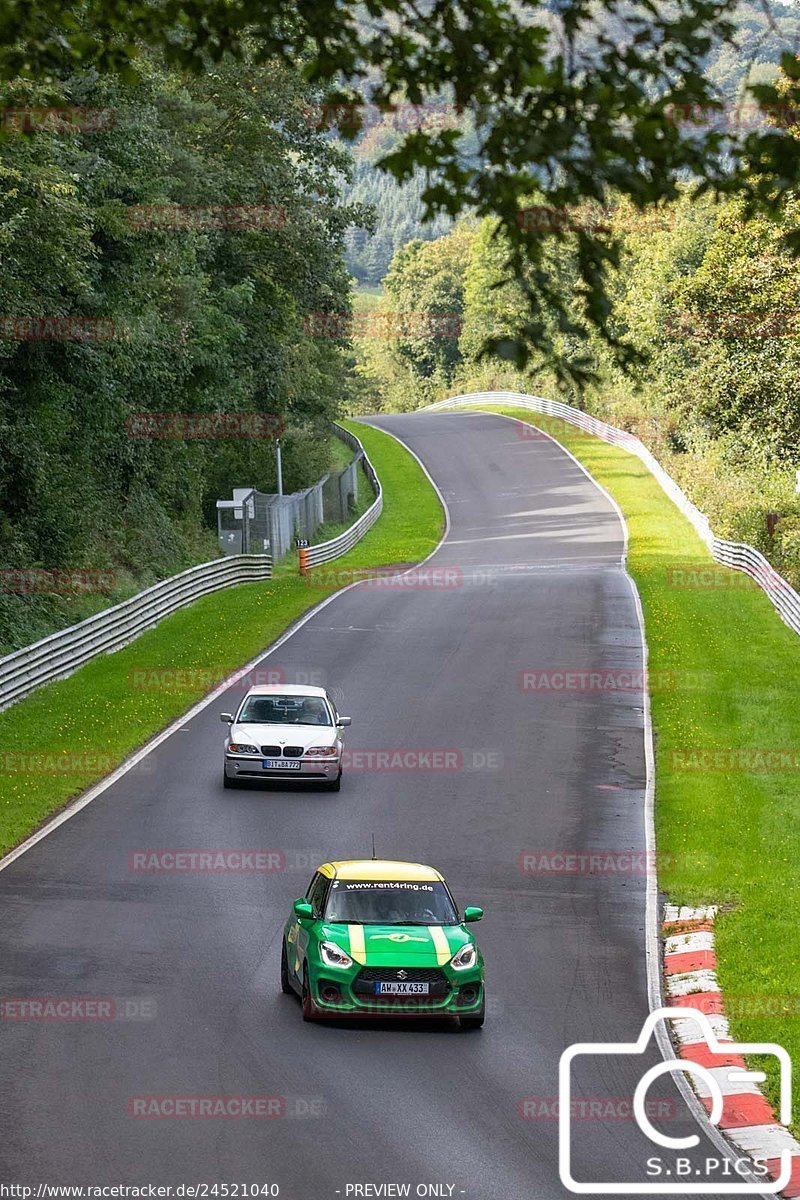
0, 0, 800, 383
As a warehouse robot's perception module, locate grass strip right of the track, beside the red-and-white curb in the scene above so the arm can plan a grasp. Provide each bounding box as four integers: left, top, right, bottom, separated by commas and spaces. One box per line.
484, 408, 800, 1112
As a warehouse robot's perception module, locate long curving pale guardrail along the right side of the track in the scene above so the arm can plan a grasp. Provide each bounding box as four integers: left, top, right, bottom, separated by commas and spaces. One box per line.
425, 391, 800, 634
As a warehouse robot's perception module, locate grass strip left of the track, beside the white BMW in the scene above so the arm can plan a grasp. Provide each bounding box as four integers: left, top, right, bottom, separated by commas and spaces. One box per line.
0, 421, 444, 853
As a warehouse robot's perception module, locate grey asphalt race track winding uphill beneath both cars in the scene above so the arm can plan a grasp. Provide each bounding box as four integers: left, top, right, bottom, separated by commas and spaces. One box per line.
0, 414, 748, 1200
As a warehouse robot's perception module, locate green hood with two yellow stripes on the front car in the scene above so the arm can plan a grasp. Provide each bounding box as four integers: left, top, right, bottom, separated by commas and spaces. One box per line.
320, 922, 473, 967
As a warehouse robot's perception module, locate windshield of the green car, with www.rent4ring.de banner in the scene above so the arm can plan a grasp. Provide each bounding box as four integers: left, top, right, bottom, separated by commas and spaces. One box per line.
325, 880, 458, 925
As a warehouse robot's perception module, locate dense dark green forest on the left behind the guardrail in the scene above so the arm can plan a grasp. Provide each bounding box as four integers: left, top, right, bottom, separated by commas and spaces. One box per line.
0, 52, 366, 646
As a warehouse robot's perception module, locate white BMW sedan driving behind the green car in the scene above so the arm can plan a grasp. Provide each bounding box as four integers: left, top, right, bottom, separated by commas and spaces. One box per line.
219, 685, 350, 792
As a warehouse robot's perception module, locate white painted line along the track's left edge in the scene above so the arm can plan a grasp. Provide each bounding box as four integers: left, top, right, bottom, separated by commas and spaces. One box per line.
0, 421, 450, 871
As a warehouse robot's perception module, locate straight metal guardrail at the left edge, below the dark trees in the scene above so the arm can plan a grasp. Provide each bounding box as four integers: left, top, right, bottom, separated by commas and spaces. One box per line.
0, 554, 272, 709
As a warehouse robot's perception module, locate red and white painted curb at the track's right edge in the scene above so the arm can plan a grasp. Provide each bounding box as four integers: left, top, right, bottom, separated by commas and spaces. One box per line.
662, 905, 800, 1196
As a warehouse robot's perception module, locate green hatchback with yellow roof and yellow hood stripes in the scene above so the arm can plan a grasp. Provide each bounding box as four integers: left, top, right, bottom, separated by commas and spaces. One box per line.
281, 859, 486, 1028
